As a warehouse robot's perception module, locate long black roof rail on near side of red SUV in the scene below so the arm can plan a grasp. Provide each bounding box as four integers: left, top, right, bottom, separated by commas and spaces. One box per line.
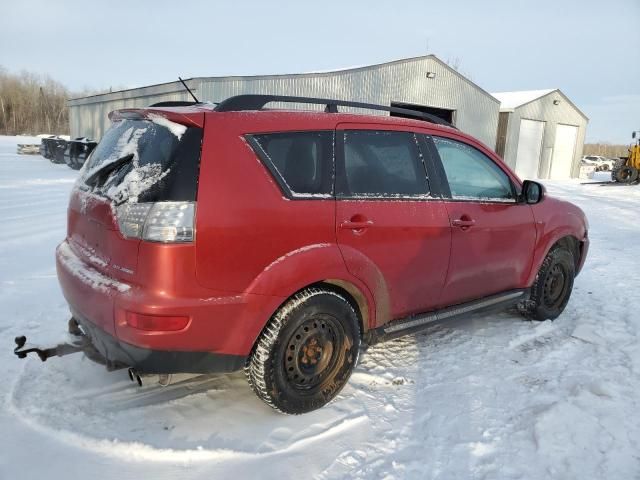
214, 94, 456, 128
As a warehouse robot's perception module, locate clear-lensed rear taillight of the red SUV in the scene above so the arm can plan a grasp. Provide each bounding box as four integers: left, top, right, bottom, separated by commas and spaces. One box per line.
116, 202, 196, 243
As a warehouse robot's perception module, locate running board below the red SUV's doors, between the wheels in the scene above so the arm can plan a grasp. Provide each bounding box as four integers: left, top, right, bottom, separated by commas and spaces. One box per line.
366, 290, 528, 345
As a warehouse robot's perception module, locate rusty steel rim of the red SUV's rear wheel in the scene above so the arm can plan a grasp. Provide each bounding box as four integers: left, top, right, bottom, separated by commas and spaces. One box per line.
283, 314, 345, 393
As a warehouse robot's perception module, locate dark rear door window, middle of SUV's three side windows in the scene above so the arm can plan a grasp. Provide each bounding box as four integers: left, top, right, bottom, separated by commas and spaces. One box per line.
338, 130, 429, 198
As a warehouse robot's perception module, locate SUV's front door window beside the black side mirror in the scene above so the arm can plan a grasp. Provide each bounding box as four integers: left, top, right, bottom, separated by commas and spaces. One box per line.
433, 137, 515, 202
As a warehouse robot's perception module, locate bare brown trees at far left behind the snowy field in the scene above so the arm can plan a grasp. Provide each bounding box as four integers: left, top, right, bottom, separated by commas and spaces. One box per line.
0, 67, 70, 135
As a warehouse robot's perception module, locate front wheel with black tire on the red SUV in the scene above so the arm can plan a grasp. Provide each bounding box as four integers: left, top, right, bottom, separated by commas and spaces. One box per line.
520, 246, 576, 321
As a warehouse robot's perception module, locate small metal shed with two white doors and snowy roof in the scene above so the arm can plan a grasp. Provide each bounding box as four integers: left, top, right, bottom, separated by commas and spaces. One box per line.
493, 89, 589, 178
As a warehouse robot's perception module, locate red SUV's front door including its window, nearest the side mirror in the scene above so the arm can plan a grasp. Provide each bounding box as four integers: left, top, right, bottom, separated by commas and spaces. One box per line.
433, 137, 536, 305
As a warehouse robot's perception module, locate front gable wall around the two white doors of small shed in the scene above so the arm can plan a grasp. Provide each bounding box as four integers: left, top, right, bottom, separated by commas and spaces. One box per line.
503, 90, 588, 178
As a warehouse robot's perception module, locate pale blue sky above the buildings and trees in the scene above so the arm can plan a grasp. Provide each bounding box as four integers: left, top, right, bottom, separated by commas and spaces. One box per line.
0, 0, 640, 143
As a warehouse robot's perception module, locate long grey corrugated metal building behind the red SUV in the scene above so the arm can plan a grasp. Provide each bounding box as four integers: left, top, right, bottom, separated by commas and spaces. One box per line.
68, 55, 499, 147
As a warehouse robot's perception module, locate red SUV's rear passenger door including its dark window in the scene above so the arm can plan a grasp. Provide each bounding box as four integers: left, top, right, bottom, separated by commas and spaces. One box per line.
336, 124, 451, 324
